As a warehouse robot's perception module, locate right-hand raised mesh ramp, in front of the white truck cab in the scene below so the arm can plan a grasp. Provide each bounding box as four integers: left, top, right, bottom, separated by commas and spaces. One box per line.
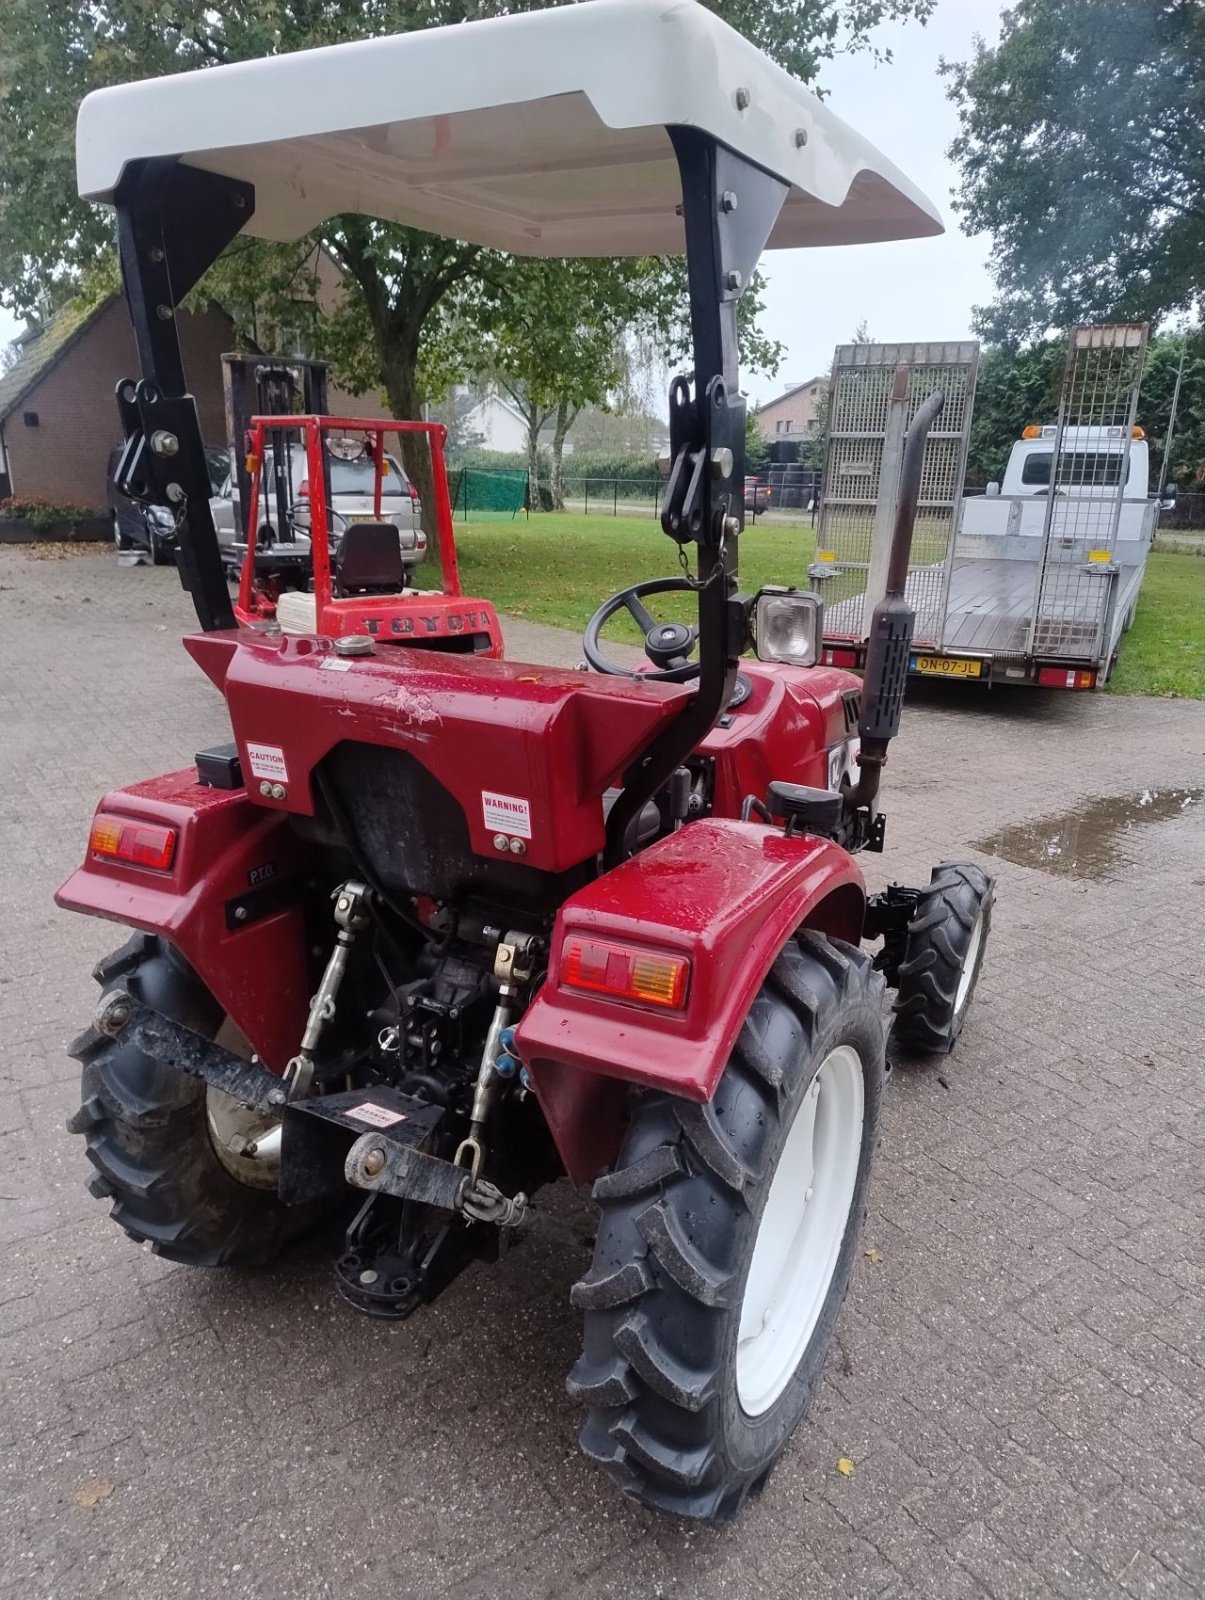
1027, 322, 1147, 667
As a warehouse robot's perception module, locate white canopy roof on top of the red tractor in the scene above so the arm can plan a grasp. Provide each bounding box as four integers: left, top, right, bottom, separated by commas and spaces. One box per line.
77, 0, 941, 256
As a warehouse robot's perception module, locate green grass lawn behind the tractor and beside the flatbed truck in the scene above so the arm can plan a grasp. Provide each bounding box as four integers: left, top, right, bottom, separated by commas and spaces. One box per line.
441, 514, 1205, 699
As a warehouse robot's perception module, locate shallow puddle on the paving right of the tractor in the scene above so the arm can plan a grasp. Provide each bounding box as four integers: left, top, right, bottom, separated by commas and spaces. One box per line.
975, 789, 1205, 878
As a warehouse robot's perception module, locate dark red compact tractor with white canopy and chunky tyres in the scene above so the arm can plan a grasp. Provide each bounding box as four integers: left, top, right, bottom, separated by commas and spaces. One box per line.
58, 0, 992, 1517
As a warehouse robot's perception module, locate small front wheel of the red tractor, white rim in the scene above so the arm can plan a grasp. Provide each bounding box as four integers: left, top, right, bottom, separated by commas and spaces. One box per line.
891, 861, 995, 1056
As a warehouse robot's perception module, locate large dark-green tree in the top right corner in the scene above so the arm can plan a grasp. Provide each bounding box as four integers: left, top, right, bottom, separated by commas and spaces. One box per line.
943, 0, 1205, 342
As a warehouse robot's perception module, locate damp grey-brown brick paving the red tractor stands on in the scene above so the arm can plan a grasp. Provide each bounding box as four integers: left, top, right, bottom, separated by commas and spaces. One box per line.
0, 549, 1205, 1600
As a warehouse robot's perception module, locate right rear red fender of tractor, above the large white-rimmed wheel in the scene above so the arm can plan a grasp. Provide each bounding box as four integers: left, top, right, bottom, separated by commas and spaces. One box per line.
515, 818, 866, 1184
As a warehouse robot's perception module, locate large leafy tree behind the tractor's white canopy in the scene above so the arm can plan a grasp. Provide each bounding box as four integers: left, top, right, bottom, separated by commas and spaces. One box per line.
0, 0, 931, 499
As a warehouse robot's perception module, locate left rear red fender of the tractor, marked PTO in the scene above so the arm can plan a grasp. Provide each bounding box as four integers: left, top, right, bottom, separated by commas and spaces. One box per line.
54, 768, 310, 1072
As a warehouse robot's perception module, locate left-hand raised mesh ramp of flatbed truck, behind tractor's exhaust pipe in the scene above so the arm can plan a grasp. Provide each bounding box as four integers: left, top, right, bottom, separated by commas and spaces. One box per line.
813, 341, 979, 643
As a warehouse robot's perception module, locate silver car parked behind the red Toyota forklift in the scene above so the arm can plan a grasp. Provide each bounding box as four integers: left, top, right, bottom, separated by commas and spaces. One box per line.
210, 450, 427, 582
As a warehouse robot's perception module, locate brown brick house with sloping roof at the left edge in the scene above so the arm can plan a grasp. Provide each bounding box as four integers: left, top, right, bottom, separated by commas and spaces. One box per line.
0, 294, 235, 510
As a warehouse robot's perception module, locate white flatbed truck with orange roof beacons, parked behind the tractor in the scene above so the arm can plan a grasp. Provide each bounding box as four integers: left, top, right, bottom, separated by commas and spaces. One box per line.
824, 323, 1159, 690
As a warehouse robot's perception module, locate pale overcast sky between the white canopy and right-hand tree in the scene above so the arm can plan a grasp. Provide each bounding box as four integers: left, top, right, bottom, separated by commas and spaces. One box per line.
0, 0, 1000, 402
